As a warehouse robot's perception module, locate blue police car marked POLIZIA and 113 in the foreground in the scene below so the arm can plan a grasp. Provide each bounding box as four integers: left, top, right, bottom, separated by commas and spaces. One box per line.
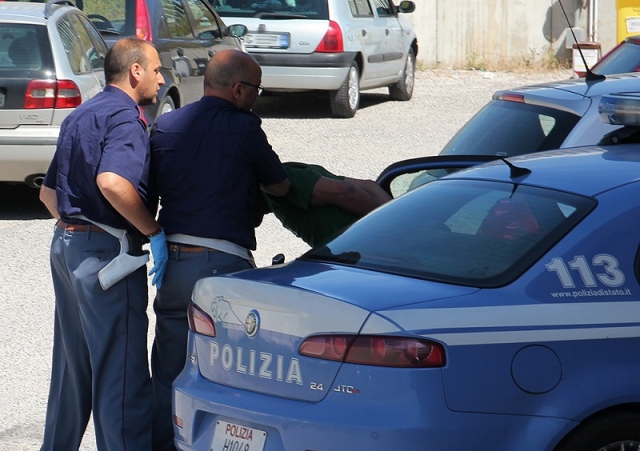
174, 95, 640, 451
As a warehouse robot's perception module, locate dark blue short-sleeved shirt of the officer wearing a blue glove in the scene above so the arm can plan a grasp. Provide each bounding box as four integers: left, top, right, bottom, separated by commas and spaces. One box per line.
44, 85, 155, 231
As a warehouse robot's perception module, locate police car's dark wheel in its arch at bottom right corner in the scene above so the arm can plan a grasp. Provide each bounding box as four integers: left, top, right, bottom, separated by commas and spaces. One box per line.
556, 412, 640, 451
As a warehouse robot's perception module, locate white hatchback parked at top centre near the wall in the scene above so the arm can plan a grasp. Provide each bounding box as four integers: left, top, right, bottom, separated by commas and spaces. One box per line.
211, 0, 418, 117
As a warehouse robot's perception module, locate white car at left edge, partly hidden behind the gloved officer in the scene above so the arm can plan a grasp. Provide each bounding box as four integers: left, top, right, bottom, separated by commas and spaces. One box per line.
0, 0, 107, 187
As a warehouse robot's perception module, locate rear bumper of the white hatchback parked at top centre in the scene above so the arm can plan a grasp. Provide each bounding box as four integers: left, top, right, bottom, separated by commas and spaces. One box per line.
251, 52, 356, 92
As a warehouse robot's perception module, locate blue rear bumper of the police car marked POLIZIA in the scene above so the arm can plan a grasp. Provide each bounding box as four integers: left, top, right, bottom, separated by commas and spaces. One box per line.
173, 333, 572, 451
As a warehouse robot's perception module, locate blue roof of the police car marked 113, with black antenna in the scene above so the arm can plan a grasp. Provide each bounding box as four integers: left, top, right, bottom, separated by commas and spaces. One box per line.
446, 144, 640, 196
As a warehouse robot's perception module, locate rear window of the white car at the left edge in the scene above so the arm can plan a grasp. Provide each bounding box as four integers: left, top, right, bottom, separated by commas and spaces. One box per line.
0, 23, 51, 71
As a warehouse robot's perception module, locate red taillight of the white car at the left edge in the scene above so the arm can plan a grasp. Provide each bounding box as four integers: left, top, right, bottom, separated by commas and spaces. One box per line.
24, 80, 82, 109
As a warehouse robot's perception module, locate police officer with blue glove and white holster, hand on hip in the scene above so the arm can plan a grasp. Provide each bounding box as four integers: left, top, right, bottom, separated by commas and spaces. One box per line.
40, 38, 167, 451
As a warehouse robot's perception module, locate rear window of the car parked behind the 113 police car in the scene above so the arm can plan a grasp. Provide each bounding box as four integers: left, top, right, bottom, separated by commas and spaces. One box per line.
440, 100, 580, 156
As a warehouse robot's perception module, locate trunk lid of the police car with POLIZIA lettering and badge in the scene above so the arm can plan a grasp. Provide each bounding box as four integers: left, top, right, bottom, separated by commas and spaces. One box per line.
193, 263, 475, 402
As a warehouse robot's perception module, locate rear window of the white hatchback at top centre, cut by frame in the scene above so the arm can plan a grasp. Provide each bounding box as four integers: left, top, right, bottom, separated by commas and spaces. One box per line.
212, 0, 329, 20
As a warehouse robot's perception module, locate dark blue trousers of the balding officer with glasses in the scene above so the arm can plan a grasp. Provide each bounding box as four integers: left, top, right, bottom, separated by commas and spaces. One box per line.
151, 249, 254, 451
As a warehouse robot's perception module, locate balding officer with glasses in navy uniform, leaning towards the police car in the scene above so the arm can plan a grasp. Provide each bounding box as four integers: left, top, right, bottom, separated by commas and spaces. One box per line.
151, 50, 289, 450
